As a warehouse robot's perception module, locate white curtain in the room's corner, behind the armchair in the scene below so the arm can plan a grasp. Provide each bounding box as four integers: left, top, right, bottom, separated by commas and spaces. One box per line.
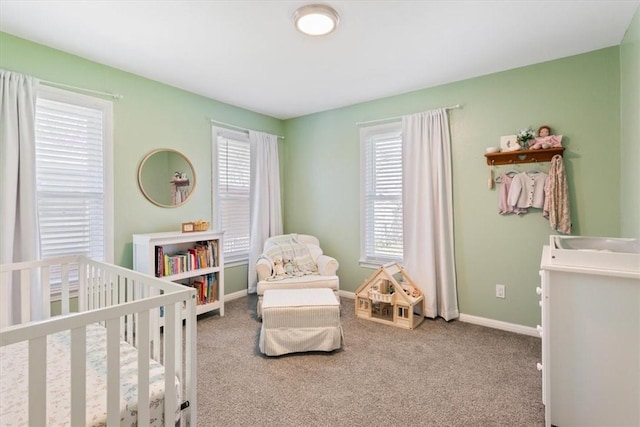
248, 131, 282, 293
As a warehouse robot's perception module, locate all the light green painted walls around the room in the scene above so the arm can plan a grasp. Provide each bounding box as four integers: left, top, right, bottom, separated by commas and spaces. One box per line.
0, 23, 640, 326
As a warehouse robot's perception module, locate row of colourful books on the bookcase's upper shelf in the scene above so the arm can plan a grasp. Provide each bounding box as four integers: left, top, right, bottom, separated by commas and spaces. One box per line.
156, 240, 218, 277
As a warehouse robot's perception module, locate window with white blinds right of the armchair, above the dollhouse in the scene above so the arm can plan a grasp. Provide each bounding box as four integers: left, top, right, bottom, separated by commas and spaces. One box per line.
360, 123, 402, 264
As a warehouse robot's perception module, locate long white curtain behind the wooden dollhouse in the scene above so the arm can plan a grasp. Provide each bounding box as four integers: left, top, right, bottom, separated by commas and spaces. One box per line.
402, 109, 459, 320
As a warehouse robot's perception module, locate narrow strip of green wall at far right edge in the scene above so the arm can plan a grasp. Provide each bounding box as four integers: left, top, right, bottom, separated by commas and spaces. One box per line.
620, 8, 640, 239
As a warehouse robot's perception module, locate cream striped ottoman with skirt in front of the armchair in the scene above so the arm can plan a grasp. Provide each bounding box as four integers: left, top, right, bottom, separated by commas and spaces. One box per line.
259, 288, 343, 356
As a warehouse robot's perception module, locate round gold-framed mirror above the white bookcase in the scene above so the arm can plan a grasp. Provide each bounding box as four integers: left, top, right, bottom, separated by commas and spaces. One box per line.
138, 148, 196, 208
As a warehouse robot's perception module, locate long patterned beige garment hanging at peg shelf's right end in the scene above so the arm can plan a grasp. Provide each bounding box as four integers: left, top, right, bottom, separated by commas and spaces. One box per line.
542, 154, 571, 234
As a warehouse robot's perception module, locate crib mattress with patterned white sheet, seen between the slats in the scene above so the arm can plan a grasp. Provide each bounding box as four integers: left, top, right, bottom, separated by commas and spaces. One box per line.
0, 324, 179, 427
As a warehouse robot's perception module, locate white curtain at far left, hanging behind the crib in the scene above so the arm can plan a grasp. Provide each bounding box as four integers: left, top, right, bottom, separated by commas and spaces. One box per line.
0, 70, 41, 325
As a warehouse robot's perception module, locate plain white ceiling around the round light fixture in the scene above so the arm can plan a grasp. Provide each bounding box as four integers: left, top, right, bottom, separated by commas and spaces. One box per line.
0, 0, 640, 119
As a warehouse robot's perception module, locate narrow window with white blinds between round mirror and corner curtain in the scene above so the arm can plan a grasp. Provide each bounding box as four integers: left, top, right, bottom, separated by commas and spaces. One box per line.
212, 127, 251, 262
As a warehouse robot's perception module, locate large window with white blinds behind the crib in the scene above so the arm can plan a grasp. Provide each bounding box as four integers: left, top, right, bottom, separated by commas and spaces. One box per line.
35, 87, 113, 290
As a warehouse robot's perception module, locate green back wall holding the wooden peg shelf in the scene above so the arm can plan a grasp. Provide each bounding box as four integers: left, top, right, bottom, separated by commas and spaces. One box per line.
284, 47, 620, 326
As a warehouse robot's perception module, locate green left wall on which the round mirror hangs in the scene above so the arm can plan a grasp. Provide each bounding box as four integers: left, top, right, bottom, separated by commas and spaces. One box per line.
0, 32, 283, 293
